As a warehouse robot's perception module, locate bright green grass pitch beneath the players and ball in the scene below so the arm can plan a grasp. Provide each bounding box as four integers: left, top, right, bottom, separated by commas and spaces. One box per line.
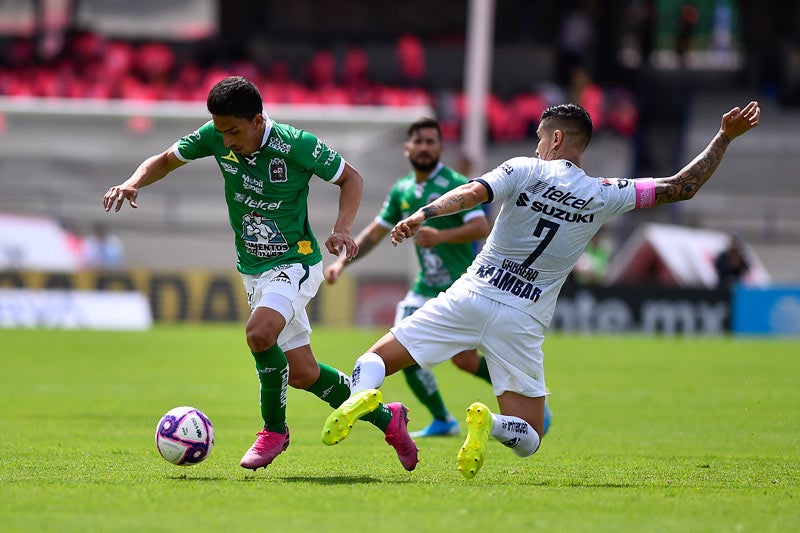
0, 326, 800, 532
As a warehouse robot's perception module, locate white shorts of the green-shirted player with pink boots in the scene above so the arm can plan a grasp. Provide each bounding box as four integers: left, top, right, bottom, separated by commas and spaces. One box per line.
242, 261, 324, 352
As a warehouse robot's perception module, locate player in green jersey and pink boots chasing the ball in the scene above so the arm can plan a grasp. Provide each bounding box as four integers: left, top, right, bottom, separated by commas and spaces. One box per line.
103, 76, 417, 470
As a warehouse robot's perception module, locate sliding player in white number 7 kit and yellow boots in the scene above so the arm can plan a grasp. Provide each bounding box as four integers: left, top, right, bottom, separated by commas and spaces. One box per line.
322, 102, 761, 478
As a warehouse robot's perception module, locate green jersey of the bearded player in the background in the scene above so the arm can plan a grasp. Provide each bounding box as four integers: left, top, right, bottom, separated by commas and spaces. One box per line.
378, 164, 483, 296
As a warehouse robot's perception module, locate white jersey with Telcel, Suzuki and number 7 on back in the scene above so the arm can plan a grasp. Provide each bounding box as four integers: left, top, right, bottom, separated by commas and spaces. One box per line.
456, 157, 652, 327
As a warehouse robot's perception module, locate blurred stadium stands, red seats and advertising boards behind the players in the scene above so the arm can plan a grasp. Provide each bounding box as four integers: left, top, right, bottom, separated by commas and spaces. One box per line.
0, 0, 800, 335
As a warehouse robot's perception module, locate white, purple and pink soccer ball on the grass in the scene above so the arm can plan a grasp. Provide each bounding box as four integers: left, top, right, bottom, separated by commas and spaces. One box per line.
156, 405, 214, 466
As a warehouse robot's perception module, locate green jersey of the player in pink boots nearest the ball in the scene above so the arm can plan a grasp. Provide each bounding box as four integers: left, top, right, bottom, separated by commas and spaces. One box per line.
173, 115, 344, 274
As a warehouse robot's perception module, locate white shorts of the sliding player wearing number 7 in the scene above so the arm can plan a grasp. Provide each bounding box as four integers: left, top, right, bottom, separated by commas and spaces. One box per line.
390, 287, 547, 398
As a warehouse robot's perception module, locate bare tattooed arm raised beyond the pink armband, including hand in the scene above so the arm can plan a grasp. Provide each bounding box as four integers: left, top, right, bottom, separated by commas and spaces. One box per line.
654, 102, 761, 205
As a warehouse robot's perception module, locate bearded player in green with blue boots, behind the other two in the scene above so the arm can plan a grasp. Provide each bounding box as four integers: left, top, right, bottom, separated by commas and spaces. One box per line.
325, 117, 491, 437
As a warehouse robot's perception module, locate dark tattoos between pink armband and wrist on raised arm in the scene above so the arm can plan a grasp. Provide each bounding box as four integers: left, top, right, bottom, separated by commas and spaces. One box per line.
655, 134, 731, 205
